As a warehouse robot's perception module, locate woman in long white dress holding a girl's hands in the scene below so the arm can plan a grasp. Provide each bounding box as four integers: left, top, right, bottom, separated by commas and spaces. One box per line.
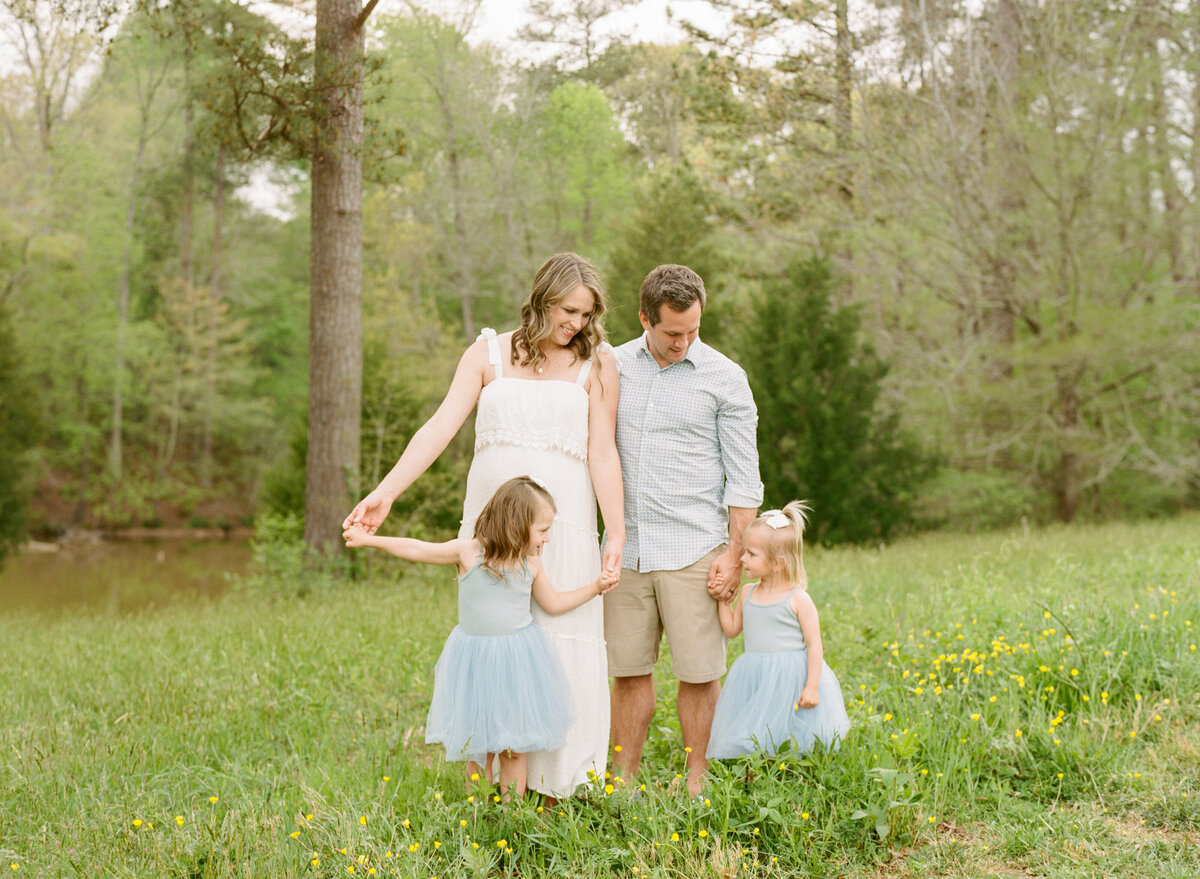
344, 253, 625, 797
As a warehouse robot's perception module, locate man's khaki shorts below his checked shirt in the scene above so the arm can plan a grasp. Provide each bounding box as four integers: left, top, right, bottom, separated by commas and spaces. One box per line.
604, 545, 725, 683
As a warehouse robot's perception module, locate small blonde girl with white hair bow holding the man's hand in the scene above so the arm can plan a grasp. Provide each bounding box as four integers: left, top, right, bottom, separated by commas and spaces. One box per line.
708, 501, 850, 759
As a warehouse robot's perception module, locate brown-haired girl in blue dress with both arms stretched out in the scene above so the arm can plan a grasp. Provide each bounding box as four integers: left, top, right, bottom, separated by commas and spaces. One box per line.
343, 477, 617, 796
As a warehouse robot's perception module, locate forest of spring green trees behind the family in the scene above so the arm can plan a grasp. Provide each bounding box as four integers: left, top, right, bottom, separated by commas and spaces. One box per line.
0, 0, 1200, 561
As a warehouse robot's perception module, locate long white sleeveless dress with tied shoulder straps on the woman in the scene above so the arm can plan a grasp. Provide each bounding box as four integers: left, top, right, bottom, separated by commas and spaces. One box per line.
458, 329, 608, 797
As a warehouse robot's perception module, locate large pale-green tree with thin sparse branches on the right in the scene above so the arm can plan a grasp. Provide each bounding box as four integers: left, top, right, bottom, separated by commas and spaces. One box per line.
856, 0, 1200, 521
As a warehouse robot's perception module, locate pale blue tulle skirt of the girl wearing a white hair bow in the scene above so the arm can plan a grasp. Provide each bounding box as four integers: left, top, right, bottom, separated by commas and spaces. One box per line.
707, 650, 850, 760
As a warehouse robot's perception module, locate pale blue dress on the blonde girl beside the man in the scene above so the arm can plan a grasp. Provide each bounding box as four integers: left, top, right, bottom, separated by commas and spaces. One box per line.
707, 584, 850, 759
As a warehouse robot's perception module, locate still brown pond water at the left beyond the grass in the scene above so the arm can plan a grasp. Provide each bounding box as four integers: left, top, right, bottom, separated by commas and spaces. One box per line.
0, 539, 251, 614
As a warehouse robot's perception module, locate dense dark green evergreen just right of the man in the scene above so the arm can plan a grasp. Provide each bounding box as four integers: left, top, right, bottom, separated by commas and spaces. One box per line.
742, 256, 932, 543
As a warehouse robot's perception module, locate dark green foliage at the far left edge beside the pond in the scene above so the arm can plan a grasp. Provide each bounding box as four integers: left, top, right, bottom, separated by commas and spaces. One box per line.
0, 304, 38, 568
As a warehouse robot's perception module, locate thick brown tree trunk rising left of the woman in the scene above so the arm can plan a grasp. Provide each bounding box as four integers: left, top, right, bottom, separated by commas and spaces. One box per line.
305, 0, 364, 550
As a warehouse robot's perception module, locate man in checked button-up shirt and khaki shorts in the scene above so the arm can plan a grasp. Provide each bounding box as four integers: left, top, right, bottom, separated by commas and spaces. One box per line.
604, 265, 762, 794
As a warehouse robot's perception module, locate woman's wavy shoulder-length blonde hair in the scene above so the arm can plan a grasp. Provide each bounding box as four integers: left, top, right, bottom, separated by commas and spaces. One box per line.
510, 253, 607, 377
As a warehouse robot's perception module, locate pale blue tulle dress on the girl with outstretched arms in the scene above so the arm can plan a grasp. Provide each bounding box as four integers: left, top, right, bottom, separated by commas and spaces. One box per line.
425, 560, 571, 760
